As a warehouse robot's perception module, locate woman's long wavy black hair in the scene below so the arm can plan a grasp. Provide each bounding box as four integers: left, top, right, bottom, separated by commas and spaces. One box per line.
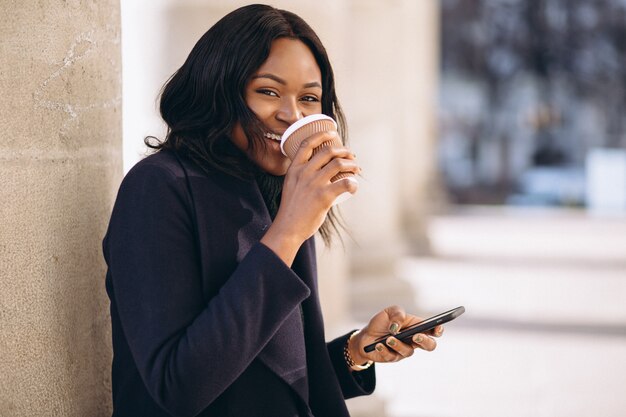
149, 4, 347, 246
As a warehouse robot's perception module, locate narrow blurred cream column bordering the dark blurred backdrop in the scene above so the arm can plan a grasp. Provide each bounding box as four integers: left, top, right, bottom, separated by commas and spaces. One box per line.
395, 0, 445, 254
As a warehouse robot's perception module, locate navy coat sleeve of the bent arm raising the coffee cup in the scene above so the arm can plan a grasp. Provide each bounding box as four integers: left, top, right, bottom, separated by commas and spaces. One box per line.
104, 164, 310, 416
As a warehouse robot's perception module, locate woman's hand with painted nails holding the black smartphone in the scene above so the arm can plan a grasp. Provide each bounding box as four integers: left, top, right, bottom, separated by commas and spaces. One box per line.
348, 306, 443, 365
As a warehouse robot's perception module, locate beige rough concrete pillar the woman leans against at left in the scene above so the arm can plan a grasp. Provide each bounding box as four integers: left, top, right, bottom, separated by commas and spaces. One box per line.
0, 0, 122, 417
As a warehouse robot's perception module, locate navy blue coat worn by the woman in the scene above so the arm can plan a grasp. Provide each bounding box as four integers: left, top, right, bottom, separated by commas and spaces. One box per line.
103, 151, 375, 417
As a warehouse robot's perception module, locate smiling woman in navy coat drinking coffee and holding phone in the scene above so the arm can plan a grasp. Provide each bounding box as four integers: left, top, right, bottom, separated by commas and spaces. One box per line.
104, 5, 442, 417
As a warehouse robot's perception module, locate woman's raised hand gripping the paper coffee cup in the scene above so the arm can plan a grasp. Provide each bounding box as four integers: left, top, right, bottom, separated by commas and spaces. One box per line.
261, 131, 361, 265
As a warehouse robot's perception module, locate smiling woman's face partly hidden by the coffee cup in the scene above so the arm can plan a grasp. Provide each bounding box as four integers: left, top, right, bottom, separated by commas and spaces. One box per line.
232, 38, 322, 175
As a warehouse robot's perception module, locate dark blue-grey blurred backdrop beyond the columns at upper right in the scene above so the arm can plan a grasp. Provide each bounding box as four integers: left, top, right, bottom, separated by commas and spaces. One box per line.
439, 0, 626, 211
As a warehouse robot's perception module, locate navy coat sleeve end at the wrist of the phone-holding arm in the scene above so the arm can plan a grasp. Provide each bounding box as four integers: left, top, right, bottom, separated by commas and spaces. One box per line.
327, 332, 376, 399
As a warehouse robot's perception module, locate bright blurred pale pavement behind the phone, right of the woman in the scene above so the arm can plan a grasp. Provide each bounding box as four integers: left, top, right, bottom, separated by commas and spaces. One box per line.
352, 208, 626, 417
